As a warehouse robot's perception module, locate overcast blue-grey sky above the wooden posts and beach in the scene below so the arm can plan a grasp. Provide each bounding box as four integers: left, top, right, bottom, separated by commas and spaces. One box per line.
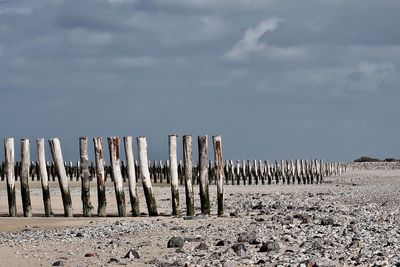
0, 0, 400, 161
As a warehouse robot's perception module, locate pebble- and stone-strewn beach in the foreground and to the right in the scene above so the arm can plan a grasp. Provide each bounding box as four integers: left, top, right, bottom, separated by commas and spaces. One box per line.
0, 170, 400, 267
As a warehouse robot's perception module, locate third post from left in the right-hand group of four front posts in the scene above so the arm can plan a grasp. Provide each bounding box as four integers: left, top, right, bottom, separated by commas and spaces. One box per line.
197, 135, 210, 215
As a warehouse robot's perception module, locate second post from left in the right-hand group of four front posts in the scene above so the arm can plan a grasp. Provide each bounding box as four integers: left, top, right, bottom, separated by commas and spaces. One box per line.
183, 135, 195, 216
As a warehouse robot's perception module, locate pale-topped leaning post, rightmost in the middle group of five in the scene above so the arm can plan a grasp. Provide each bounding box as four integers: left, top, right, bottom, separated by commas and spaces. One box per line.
137, 136, 158, 216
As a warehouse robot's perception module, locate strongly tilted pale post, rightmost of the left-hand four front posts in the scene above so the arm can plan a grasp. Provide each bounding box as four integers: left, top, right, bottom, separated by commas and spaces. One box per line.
49, 138, 73, 217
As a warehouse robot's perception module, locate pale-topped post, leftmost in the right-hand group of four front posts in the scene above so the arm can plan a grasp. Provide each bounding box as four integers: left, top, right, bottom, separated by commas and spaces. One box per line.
168, 134, 181, 216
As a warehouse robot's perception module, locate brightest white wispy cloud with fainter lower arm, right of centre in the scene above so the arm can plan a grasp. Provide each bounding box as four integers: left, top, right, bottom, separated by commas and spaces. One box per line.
225, 17, 306, 61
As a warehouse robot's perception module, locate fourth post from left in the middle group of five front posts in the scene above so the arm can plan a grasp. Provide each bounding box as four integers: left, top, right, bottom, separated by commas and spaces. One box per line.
124, 136, 140, 217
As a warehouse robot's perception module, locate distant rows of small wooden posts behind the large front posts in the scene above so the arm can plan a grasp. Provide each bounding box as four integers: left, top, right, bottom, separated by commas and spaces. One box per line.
0, 159, 344, 185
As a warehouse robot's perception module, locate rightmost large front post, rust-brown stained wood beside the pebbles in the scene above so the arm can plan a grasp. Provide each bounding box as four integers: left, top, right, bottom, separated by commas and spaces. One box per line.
213, 135, 224, 215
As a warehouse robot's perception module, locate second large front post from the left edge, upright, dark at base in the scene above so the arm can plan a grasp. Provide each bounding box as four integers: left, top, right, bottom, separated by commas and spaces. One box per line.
21, 139, 32, 217
